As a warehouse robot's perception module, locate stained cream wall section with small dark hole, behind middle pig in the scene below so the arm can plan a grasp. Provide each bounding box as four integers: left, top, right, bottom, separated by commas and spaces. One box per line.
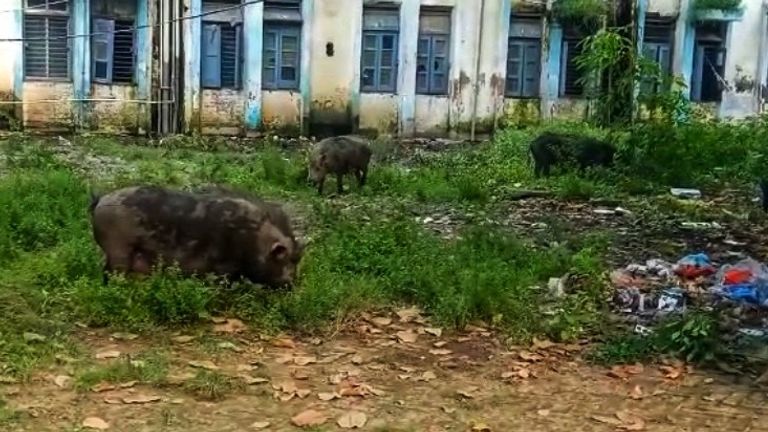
309, 0, 363, 131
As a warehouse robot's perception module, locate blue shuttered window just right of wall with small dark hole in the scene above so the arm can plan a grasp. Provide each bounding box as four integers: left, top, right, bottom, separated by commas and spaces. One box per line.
360, 7, 400, 93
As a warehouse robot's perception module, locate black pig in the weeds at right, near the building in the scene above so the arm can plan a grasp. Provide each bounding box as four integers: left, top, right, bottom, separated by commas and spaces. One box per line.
530, 132, 616, 177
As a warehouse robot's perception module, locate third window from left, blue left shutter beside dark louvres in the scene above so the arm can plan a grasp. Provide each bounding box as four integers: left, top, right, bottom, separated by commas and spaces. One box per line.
201, 22, 241, 89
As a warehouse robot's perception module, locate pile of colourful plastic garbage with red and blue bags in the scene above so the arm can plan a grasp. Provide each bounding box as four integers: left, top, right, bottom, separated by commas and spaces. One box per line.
611, 253, 768, 332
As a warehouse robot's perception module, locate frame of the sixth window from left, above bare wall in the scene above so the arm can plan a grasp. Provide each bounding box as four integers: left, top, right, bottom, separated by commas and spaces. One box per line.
416, 8, 453, 96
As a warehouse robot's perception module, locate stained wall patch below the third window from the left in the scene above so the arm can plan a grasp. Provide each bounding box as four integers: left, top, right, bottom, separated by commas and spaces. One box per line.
200, 89, 245, 135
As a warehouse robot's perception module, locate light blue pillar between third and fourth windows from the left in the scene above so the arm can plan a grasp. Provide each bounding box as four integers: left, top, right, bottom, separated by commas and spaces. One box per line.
243, 2, 266, 132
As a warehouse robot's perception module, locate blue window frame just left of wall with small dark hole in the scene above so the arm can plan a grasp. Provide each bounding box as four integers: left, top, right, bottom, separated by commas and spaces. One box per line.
261, 21, 303, 90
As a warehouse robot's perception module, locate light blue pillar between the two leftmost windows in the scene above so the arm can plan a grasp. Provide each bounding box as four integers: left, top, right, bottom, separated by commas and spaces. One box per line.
70, 0, 91, 128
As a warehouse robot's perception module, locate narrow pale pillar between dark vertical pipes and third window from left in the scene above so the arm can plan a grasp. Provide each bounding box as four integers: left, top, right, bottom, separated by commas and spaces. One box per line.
184, 0, 201, 132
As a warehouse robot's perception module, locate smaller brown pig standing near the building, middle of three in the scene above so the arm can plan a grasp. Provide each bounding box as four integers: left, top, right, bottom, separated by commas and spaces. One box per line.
307, 135, 372, 195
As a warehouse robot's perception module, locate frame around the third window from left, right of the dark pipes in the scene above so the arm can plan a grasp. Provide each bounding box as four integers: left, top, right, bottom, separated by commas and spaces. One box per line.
200, 21, 243, 90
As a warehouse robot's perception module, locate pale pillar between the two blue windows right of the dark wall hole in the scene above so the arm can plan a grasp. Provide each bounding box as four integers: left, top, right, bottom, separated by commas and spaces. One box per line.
397, 0, 420, 137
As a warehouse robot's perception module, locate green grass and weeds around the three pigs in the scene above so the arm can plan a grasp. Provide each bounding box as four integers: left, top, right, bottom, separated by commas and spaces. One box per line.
0, 119, 768, 374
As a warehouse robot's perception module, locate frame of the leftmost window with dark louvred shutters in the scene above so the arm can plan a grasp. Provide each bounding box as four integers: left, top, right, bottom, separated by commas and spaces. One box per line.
21, 0, 72, 82
